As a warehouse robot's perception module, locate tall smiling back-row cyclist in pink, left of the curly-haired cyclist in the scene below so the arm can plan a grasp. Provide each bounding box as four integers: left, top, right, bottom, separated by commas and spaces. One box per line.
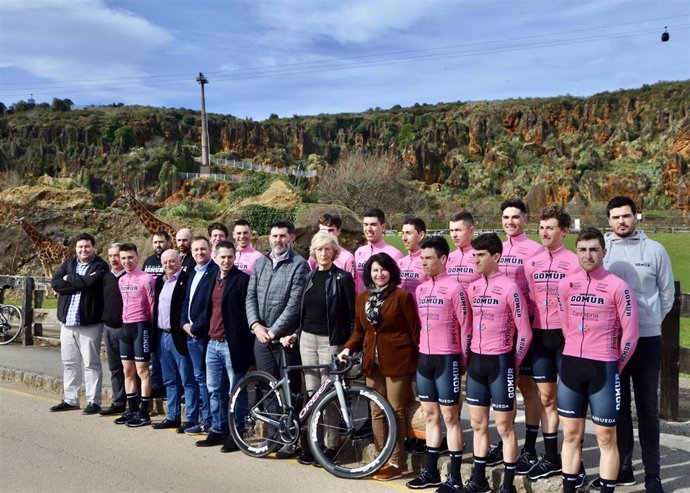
488, 199, 544, 474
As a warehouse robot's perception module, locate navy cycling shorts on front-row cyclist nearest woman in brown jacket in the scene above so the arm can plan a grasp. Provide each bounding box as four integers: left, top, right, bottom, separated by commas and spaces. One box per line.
417, 353, 462, 406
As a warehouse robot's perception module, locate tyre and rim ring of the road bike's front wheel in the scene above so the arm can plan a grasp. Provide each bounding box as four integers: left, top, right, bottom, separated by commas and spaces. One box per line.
308, 384, 398, 479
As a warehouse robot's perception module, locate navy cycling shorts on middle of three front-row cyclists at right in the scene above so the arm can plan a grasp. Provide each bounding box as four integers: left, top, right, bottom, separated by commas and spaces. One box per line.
465, 352, 515, 412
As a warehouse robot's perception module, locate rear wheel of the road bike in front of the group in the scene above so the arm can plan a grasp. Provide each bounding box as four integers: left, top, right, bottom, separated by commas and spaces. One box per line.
228, 371, 286, 457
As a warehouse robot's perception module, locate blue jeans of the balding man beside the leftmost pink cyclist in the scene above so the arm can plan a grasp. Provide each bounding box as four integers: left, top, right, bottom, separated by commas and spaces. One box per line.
158, 331, 199, 423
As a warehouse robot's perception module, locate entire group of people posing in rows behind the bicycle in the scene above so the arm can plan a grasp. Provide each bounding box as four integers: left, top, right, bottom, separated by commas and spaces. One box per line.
52, 196, 674, 493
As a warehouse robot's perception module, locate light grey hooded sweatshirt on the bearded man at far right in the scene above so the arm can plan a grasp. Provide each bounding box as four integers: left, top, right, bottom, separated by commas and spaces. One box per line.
604, 230, 675, 337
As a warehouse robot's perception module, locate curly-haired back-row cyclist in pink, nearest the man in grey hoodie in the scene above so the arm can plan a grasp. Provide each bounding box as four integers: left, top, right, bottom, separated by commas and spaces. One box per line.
518, 206, 585, 482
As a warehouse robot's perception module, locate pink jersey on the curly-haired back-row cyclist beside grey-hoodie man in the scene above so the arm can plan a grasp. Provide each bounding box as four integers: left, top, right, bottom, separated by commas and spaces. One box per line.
525, 246, 580, 330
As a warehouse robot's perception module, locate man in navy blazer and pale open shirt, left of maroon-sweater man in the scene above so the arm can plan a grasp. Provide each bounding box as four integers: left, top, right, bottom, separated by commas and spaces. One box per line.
180, 236, 219, 435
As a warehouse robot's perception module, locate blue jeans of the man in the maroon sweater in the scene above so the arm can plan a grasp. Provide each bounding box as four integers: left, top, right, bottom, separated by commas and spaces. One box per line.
206, 340, 247, 434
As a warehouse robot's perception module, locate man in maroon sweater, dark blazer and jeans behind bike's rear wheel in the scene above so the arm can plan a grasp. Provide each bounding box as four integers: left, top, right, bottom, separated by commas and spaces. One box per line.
196, 240, 254, 452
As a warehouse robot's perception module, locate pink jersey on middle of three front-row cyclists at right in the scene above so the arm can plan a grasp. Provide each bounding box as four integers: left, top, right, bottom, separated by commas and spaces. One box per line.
467, 272, 532, 366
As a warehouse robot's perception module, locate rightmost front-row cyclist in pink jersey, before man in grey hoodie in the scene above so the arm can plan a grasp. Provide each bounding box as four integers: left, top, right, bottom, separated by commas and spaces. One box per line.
558, 228, 639, 493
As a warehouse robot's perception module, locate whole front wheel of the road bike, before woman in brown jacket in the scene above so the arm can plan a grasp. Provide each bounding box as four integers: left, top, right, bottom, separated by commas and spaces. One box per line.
308, 385, 398, 479
